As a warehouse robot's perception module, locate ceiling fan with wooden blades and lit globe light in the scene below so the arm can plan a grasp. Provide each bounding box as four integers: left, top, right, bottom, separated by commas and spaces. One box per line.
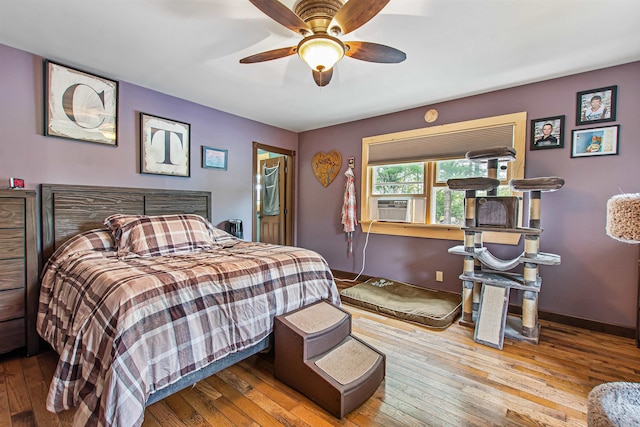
240, 0, 407, 86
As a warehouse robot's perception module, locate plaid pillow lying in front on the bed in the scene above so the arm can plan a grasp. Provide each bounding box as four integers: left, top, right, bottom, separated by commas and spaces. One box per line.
104, 214, 215, 256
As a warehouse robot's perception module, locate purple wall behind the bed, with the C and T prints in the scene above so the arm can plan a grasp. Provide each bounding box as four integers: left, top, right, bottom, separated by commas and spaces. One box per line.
0, 45, 298, 236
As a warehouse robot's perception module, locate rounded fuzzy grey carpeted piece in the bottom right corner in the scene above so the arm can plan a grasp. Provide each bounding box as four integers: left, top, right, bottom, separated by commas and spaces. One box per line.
587, 382, 640, 427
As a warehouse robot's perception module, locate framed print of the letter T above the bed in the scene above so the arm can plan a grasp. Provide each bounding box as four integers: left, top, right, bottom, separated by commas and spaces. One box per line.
140, 113, 191, 176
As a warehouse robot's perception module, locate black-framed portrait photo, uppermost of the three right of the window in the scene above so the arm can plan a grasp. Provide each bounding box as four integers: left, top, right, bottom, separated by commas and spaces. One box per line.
576, 86, 618, 126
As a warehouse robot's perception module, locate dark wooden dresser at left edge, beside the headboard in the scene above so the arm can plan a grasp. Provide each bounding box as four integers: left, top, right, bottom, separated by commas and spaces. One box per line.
0, 190, 39, 355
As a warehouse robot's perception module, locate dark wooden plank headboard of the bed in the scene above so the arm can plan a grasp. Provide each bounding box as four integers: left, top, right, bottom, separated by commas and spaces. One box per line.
40, 184, 211, 261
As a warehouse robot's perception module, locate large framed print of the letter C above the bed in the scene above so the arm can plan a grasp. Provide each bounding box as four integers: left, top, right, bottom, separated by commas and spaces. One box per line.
44, 61, 118, 145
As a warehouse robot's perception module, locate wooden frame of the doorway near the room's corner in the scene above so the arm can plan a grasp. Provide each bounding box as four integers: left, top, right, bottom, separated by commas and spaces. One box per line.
251, 141, 296, 246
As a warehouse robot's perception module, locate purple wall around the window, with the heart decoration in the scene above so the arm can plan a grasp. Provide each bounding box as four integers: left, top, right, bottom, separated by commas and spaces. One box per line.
298, 62, 640, 327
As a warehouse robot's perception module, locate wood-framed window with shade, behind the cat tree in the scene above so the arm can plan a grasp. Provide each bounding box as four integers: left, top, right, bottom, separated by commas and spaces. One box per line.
361, 113, 526, 243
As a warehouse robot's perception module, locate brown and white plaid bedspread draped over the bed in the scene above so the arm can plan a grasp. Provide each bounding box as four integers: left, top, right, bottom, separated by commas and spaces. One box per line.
37, 241, 340, 426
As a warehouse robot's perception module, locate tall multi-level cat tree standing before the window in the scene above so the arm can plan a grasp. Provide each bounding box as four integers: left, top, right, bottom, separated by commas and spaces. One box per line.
447, 147, 564, 349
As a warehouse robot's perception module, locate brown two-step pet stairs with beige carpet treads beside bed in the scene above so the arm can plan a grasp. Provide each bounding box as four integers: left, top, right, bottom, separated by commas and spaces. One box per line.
273, 301, 385, 418
